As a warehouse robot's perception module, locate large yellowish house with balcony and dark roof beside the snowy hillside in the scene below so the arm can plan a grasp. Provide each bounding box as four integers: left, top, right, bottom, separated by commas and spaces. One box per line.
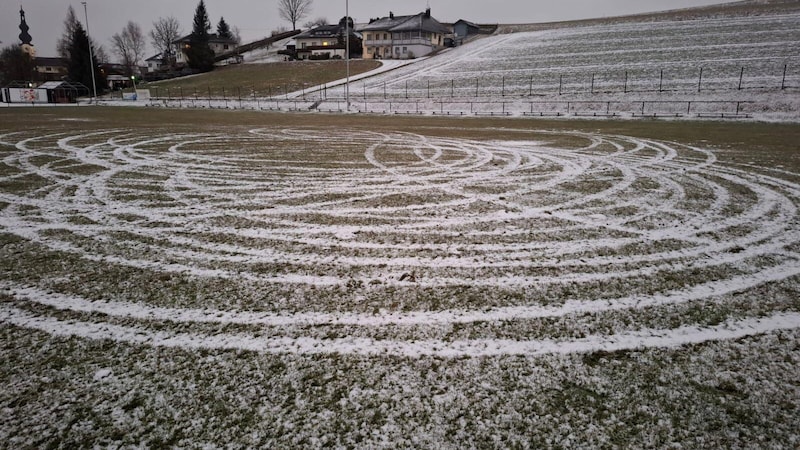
359, 8, 451, 59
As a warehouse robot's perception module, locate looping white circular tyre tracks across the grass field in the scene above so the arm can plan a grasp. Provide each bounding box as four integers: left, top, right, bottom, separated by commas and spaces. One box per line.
0, 128, 800, 356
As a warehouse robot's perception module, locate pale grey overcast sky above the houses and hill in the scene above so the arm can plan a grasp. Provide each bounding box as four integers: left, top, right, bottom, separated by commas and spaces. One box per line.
0, 0, 736, 59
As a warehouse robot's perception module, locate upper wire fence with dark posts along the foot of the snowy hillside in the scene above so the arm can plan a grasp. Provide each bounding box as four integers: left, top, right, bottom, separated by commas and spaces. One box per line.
141, 64, 800, 102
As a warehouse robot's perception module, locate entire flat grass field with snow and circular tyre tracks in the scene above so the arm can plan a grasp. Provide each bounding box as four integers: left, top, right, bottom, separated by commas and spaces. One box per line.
0, 107, 800, 448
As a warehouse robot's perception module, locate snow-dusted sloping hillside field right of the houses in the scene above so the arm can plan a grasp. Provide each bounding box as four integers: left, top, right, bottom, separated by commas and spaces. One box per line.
306, 7, 800, 121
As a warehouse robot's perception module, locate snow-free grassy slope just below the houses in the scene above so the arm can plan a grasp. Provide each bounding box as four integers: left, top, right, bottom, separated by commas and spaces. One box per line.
141, 60, 381, 96
